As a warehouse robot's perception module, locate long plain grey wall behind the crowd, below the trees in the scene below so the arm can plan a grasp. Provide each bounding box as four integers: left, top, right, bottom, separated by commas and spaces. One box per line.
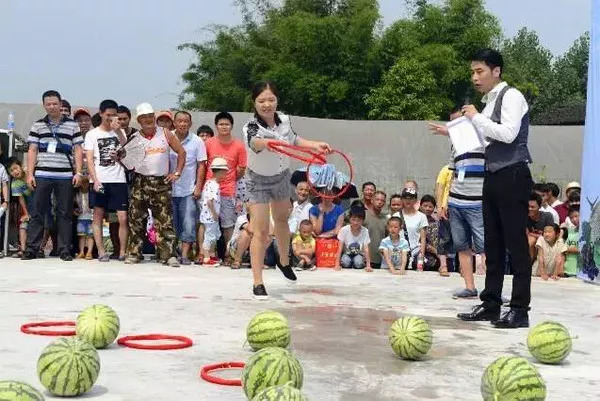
0, 103, 583, 193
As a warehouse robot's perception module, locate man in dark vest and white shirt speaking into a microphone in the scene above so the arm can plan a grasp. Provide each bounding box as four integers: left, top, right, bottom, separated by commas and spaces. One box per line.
430, 49, 533, 328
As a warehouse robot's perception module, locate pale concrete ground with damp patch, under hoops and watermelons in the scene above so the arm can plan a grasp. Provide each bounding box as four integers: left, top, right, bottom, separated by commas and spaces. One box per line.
0, 258, 600, 401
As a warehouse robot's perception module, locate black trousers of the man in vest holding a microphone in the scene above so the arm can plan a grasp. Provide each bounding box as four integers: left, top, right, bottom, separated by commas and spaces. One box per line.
480, 163, 533, 310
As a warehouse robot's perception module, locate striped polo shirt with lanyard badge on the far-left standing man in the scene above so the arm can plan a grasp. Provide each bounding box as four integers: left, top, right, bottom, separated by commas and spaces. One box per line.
27, 116, 83, 180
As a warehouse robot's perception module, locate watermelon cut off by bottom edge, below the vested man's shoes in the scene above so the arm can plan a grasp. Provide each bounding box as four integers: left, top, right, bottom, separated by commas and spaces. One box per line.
481, 356, 546, 401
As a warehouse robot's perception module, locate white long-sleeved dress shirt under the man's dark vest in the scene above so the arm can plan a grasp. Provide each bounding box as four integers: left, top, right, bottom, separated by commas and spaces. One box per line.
471, 82, 529, 146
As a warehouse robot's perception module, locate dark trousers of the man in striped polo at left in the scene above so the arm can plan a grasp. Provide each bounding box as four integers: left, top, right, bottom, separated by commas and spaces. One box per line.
27, 178, 74, 254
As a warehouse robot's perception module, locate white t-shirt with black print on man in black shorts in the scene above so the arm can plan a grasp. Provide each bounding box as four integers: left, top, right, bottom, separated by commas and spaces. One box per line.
83, 127, 127, 184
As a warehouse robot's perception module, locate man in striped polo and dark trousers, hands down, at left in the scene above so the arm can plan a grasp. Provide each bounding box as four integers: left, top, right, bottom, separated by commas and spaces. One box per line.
23, 90, 83, 261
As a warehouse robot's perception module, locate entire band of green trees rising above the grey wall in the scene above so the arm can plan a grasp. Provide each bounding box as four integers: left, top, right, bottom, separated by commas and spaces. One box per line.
179, 0, 589, 122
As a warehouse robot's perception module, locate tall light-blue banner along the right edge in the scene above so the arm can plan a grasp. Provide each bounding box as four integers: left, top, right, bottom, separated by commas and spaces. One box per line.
578, 0, 600, 284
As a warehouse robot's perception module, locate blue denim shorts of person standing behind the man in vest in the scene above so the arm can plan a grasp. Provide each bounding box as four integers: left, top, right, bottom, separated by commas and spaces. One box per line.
448, 205, 485, 254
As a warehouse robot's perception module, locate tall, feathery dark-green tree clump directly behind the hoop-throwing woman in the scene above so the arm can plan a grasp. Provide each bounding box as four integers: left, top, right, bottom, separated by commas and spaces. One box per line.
180, 0, 380, 118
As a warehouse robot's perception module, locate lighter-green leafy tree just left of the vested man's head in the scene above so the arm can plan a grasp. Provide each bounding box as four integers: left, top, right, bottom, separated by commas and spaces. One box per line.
366, 0, 501, 120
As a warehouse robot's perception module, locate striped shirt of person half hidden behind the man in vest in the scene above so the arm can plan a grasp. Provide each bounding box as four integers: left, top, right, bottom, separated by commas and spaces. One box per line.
448, 147, 485, 208
